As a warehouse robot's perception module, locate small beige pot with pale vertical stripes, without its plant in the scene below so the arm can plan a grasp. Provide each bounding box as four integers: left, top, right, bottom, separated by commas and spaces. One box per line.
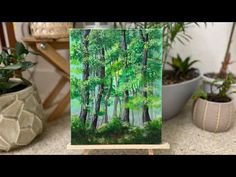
193, 98, 234, 133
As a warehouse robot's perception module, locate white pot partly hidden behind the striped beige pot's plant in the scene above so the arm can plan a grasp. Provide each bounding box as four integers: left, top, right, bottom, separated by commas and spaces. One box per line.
202, 75, 236, 110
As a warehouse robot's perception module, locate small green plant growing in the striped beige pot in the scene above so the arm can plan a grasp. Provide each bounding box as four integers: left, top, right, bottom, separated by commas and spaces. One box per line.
192, 73, 236, 102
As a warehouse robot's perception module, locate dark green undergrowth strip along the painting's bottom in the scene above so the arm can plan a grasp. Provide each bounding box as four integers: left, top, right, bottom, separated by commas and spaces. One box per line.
71, 116, 162, 144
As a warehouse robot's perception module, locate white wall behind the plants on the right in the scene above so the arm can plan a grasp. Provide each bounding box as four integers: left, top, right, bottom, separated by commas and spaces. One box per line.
170, 22, 236, 73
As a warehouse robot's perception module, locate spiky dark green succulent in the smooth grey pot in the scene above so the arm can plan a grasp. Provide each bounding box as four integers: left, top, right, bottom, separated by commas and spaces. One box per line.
167, 54, 198, 78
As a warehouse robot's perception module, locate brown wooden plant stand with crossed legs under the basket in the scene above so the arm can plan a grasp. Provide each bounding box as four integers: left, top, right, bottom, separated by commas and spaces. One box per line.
23, 37, 70, 121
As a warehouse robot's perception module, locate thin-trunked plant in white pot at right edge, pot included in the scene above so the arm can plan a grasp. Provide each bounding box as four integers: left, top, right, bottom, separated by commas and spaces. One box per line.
202, 22, 236, 106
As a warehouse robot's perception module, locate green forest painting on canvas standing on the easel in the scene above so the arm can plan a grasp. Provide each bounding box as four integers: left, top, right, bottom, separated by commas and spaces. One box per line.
70, 29, 162, 145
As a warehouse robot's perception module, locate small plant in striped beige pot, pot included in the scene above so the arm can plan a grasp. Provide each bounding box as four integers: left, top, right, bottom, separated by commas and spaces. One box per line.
193, 74, 235, 132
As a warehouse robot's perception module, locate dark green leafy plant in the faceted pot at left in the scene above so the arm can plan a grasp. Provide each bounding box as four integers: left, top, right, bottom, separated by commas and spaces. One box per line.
0, 42, 36, 94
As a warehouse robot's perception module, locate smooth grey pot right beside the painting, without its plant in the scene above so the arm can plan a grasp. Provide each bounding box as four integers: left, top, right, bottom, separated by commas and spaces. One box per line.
162, 71, 201, 120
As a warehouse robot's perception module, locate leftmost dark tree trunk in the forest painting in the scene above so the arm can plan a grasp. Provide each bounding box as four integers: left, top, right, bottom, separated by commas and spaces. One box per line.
80, 30, 90, 123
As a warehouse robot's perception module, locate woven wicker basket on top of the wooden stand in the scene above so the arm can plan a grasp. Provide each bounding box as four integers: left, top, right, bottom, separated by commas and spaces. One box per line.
30, 22, 73, 39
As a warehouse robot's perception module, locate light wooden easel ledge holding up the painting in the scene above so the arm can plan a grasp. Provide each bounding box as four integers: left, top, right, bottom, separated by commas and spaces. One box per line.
67, 143, 170, 155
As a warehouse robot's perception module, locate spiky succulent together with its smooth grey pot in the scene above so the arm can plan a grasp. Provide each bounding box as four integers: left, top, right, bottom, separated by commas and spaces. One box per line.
162, 55, 201, 119
